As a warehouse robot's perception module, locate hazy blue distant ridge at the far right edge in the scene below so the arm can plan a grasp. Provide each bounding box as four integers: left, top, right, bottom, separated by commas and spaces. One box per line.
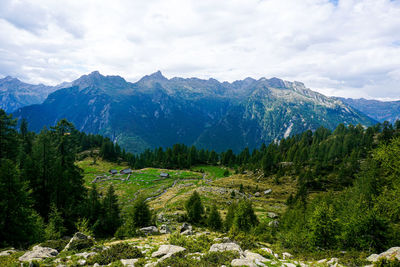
339, 98, 400, 123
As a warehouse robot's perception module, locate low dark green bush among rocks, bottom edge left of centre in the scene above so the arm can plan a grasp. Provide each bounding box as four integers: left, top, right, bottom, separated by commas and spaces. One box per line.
88, 243, 143, 265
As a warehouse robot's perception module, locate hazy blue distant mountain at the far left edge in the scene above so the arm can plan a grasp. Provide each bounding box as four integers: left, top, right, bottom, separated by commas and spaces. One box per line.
0, 76, 57, 112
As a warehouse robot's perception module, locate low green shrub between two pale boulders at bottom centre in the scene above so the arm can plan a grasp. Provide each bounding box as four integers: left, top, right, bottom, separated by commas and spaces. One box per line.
169, 234, 212, 252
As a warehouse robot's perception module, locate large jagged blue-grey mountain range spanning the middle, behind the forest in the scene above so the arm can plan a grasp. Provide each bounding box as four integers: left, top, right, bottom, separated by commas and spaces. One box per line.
14, 72, 375, 152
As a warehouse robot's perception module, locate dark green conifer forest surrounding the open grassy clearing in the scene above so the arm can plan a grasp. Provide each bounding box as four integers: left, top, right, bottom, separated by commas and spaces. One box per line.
0, 108, 400, 266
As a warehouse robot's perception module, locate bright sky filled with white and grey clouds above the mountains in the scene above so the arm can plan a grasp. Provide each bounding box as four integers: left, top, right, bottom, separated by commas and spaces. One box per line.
0, 0, 400, 100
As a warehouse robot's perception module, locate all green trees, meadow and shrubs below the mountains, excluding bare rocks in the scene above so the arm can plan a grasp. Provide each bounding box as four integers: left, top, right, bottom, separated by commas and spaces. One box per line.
0, 111, 400, 266
